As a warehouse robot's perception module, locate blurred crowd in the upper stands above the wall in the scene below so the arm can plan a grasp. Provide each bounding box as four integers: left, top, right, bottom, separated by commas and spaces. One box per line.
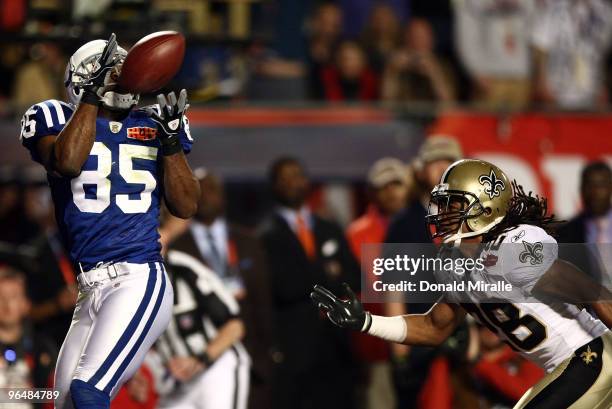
0, 0, 612, 113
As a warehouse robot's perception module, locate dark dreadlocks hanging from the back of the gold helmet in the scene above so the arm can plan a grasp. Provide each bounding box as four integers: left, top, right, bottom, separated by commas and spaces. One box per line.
483, 180, 562, 242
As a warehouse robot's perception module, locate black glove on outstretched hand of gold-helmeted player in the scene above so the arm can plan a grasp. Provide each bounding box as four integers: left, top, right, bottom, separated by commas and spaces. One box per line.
310, 283, 372, 332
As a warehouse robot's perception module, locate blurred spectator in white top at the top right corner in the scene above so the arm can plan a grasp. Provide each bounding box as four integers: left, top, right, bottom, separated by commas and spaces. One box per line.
532, 0, 612, 109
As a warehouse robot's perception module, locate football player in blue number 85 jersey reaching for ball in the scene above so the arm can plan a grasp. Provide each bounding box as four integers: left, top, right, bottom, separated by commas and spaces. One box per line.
21, 34, 199, 409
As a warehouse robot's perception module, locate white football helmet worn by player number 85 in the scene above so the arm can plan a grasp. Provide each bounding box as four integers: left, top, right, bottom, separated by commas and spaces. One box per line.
64, 40, 139, 110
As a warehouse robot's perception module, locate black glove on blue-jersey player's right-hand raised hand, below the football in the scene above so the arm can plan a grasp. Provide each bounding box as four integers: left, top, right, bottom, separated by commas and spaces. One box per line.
147, 89, 189, 155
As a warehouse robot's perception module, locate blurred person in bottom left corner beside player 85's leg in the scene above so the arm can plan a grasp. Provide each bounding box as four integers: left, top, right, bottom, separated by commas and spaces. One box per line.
0, 264, 57, 400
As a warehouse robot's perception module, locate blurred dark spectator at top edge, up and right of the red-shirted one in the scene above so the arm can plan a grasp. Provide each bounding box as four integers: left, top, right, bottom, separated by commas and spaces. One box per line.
361, 3, 401, 75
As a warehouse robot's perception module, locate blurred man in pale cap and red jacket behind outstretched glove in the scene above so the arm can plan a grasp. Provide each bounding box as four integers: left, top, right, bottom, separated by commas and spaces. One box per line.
347, 158, 409, 409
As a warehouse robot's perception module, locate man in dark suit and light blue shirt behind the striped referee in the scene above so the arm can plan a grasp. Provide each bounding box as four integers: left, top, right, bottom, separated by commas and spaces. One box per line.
170, 168, 272, 409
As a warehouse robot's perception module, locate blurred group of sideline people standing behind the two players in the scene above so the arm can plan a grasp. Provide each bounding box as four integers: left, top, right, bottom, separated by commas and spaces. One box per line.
0, 135, 612, 409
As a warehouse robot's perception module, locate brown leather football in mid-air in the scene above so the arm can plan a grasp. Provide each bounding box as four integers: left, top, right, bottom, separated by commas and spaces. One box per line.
119, 31, 185, 94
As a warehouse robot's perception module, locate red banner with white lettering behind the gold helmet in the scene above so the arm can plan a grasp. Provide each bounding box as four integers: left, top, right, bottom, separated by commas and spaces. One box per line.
429, 112, 612, 218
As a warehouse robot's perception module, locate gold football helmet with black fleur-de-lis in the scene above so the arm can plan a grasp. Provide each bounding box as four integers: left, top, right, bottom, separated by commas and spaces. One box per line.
427, 159, 512, 243
